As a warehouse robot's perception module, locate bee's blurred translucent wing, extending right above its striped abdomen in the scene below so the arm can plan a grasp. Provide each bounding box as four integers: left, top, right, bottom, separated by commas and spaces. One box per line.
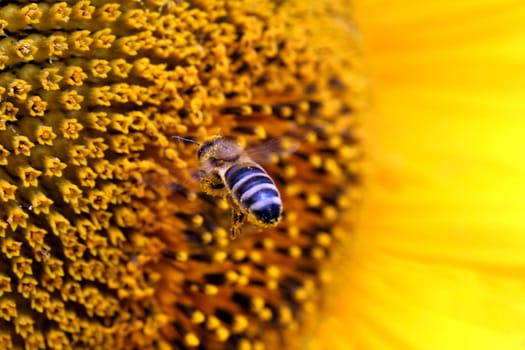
246, 138, 300, 164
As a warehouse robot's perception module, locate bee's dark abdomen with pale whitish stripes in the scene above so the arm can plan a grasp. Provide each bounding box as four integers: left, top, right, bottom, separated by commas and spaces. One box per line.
224, 163, 282, 225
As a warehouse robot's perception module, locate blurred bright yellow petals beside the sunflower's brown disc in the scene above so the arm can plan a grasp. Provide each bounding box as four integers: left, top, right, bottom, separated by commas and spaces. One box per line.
316, 0, 525, 350
